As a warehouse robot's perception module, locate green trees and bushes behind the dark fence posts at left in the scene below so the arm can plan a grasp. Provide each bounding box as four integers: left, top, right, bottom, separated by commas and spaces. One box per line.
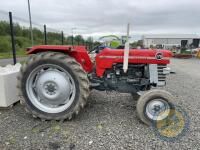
0, 21, 95, 58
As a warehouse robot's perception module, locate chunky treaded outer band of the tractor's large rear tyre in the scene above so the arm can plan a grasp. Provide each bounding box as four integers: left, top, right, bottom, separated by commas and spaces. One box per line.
17, 52, 90, 121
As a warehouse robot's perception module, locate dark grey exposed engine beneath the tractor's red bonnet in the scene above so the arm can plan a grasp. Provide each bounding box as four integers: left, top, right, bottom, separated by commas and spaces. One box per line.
88, 63, 151, 93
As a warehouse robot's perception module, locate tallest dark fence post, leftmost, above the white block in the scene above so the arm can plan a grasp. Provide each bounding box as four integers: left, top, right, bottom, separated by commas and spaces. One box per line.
9, 12, 17, 65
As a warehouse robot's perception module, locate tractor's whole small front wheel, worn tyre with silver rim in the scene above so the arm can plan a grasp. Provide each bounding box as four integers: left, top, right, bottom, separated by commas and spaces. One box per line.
136, 90, 175, 126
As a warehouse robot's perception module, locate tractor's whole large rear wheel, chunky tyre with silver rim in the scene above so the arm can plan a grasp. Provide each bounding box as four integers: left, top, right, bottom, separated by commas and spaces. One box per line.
18, 52, 89, 120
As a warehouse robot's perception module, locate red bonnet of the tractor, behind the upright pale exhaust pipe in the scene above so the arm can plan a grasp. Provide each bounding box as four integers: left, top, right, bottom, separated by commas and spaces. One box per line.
96, 48, 172, 77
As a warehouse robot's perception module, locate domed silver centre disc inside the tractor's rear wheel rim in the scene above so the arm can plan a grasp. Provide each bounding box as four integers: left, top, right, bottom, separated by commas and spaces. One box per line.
36, 69, 73, 105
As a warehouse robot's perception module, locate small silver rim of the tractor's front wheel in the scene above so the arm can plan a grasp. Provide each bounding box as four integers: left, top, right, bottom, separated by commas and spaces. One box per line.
146, 99, 170, 121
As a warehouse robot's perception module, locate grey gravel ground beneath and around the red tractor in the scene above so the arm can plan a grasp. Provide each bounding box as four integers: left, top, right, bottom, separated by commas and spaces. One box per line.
0, 59, 200, 150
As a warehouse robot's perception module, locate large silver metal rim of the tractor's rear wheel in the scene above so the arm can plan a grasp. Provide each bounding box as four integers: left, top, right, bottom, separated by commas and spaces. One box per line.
26, 64, 76, 113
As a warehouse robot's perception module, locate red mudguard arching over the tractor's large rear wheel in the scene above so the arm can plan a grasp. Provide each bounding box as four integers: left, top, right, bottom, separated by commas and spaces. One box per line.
27, 45, 93, 73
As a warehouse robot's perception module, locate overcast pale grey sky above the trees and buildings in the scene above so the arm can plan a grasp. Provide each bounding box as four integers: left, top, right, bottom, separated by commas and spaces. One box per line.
0, 0, 200, 36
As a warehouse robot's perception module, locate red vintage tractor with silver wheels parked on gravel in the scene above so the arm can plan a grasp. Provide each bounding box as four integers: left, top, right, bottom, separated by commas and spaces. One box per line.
18, 45, 173, 125
